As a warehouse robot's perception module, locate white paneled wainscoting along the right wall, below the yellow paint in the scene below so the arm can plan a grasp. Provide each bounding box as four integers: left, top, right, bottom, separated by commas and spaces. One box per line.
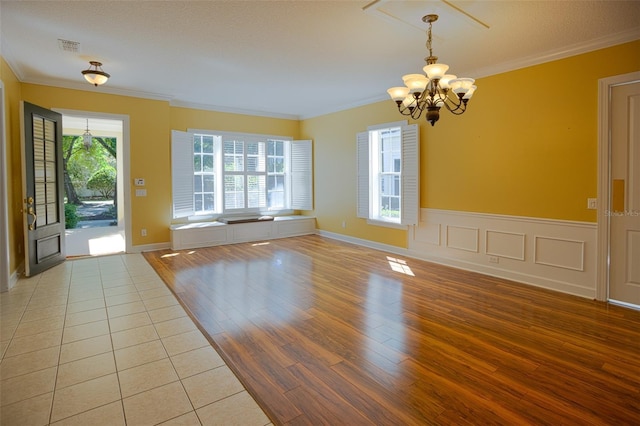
408, 209, 597, 298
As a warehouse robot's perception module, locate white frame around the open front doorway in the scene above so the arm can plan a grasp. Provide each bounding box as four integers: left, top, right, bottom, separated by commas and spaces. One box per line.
52, 108, 133, 253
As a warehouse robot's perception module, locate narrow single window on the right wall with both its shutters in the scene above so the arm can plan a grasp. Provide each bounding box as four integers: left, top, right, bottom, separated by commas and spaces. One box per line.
357, 122, 419, 226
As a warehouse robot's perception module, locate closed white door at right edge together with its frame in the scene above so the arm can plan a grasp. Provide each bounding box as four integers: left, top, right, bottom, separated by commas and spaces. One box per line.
597, 72, 640, 309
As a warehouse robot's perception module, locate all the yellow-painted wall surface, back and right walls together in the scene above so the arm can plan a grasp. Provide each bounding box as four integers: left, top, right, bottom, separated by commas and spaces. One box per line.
5, 41, 640, 276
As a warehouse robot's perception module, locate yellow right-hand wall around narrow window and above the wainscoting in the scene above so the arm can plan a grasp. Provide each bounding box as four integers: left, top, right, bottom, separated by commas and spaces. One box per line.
301, 41, 640, 247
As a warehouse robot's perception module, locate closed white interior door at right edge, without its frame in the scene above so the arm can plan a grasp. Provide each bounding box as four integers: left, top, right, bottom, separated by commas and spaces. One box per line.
609, 82, 640, 306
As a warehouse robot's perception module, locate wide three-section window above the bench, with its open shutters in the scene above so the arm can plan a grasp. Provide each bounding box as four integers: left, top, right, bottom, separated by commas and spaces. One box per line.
171, 130, 313, 218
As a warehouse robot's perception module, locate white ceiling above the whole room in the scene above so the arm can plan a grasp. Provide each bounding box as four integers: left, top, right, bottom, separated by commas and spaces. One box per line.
0, 0, 640, 119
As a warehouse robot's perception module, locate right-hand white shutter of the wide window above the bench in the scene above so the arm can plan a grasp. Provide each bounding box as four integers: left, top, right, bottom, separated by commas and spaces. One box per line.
291, 141, 313, 210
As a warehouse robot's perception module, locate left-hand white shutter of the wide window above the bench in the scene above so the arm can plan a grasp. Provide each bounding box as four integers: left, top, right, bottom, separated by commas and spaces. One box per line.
171, 130, 195, 219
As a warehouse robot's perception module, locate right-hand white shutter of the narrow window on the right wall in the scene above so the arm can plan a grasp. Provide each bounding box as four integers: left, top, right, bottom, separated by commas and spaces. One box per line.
400, 124, 420, 225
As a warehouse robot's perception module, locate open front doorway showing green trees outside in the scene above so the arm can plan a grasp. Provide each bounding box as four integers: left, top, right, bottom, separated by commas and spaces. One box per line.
58, 110, 131, 257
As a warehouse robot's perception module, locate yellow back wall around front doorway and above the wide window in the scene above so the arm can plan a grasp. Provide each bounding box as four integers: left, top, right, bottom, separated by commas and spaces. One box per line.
5, 80, 300, 270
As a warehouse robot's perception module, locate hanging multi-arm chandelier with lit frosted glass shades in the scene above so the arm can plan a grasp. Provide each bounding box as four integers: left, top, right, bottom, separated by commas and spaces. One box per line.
387, 15, 476, 126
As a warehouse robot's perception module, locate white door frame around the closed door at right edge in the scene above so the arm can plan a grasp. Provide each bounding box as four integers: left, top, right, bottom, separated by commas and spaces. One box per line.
596, 71, 640, 301
